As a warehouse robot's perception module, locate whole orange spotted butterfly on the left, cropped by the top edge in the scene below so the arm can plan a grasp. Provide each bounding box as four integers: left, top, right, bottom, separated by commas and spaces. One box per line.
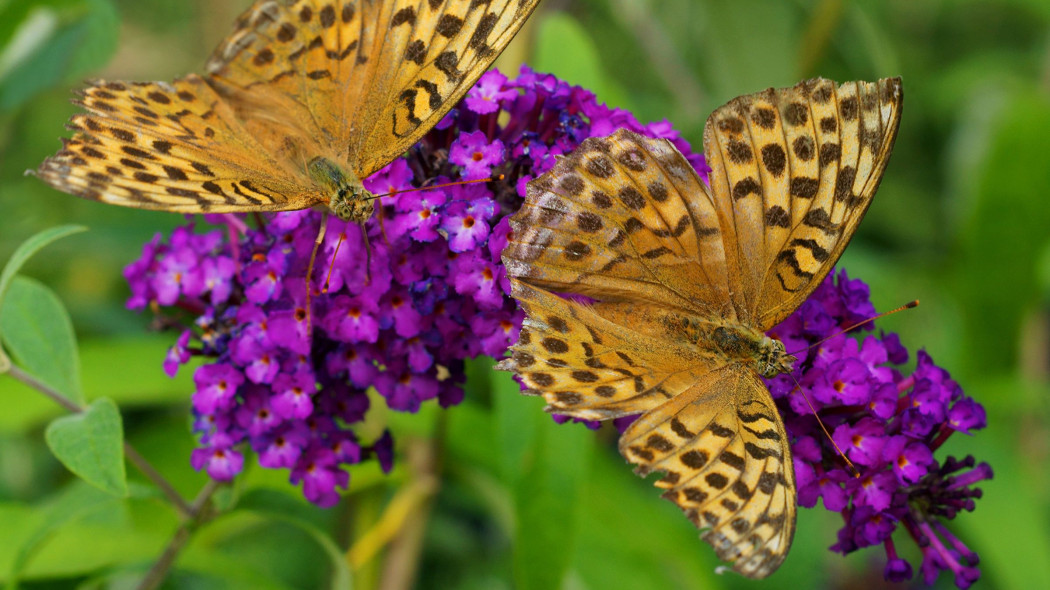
35, 0, 539, 223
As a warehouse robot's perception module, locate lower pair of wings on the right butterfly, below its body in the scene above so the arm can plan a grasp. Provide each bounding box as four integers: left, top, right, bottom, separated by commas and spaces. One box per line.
498, 279, 795, 577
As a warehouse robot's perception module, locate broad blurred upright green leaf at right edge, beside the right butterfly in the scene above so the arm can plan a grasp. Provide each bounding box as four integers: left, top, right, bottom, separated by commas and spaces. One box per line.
953, 88, 1050, 377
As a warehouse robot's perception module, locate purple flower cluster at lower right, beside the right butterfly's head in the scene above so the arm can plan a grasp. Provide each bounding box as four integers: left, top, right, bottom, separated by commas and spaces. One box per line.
767, 270, 992, 588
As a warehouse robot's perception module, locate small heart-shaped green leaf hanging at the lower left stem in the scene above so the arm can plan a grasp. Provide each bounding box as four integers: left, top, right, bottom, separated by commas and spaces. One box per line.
44, 398, 128, 498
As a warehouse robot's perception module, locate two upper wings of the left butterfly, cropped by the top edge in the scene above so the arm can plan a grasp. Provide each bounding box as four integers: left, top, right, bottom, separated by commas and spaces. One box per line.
207, 0, 539, 177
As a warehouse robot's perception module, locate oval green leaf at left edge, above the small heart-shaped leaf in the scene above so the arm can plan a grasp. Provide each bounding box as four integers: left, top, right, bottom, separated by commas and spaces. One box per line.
0, 276, 84, 405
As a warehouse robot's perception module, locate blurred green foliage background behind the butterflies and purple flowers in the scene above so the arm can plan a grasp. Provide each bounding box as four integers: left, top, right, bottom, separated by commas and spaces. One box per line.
0, 0, 1050, 589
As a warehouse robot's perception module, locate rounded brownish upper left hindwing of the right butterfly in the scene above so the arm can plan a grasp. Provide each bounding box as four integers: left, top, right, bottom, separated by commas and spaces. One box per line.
503, 129, 735, 319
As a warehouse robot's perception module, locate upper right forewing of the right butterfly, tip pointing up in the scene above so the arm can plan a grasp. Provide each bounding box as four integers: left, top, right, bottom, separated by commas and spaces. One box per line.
704, 78, 903, 330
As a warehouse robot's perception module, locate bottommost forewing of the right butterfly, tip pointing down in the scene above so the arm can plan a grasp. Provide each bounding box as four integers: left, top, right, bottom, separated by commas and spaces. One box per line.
620, 364, 796, 577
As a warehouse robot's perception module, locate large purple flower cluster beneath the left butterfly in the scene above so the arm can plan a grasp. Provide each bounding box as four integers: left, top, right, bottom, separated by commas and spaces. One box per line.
125, 68, 706, 506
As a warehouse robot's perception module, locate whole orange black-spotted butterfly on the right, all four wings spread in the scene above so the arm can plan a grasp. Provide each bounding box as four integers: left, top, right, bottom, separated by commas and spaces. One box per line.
498, 78, 903, 577
